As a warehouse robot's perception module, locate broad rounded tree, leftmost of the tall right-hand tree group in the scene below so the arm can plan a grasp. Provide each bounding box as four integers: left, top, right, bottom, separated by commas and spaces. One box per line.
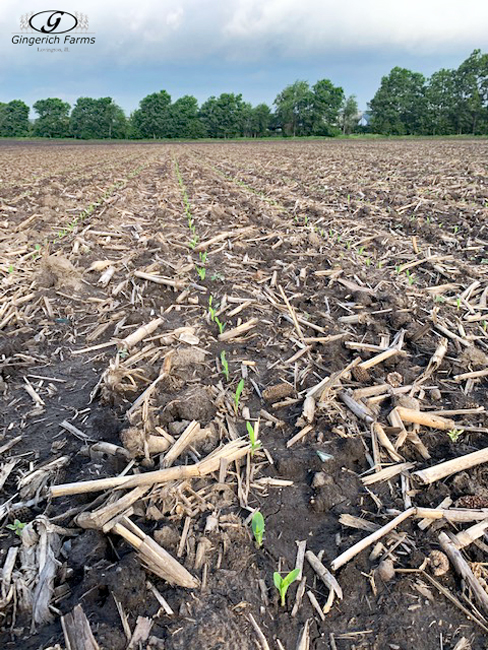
369, 67, 426, 135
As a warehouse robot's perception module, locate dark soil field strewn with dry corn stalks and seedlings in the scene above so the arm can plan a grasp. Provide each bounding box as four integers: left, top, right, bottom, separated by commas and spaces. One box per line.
0, 140, 488, 650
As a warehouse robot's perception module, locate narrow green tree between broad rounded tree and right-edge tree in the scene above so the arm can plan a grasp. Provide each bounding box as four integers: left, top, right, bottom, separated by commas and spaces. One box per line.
424, 68, 459, 135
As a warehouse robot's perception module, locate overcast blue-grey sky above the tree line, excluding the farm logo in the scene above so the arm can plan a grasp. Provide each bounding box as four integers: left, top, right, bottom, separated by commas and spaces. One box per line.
0, 0, 488, 112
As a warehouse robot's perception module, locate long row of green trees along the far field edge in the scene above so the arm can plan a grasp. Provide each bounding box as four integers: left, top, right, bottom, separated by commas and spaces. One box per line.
0, 50, 488, 139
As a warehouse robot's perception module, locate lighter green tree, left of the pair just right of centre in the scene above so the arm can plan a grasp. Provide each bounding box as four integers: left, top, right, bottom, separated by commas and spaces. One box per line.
273, 80, 315, 136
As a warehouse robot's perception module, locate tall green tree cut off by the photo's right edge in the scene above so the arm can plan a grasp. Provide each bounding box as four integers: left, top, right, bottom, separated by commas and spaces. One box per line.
456, 50, 488, 134
